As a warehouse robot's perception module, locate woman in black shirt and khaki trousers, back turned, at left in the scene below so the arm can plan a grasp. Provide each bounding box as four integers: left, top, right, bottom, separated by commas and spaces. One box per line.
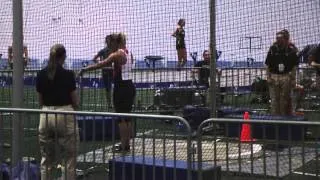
36, 44, 79, 179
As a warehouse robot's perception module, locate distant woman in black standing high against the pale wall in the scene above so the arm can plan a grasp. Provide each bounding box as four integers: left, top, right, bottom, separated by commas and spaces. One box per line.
172, 19, 187, 67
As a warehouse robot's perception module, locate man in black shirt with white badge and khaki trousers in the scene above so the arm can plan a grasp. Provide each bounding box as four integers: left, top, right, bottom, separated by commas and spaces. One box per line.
265, 30, 299, 115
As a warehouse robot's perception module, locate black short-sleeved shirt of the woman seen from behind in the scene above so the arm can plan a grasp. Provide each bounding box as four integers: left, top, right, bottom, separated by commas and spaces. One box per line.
36, 65, 76, 106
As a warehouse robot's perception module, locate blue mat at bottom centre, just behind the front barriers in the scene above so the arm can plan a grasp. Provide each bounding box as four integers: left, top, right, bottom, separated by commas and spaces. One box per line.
109, 156, 221, 180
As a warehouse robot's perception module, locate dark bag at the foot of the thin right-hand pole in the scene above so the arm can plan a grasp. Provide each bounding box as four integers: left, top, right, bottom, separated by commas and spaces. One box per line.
183, 105, 210, 130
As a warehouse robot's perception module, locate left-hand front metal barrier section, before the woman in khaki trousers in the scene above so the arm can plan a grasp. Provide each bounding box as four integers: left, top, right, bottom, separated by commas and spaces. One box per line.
0, 107, 192, 180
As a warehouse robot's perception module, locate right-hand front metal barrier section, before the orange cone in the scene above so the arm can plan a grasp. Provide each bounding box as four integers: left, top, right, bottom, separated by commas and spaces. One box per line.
196, 116, 320, 180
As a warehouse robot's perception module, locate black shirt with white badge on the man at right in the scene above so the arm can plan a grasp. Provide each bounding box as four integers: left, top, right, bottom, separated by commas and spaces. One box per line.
265, 43, 299, 74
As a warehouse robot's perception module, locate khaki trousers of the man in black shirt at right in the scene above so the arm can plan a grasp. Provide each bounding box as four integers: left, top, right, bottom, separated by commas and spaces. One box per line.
268, 74, 292, 115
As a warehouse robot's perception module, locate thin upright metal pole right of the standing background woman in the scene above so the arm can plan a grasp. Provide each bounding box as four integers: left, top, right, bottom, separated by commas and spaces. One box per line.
209, 0, 217, 117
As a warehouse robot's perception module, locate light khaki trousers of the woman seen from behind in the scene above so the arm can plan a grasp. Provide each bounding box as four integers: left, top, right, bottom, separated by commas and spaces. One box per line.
39, 106, 79, 180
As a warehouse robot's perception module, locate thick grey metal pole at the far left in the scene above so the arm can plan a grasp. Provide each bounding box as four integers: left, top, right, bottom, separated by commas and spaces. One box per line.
12, 0, 24, 166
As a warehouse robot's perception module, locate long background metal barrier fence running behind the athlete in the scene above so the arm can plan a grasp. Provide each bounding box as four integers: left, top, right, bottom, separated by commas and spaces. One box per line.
0, 67, 319, 115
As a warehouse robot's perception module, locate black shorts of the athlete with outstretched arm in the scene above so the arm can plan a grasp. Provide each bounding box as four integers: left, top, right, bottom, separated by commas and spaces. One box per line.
113, 80, 136, 113
